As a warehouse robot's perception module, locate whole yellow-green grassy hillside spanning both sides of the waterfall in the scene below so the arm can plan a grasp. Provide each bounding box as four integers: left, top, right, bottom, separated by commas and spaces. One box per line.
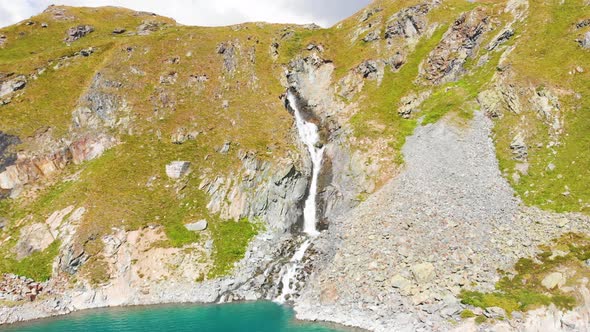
0, 0, 590, 278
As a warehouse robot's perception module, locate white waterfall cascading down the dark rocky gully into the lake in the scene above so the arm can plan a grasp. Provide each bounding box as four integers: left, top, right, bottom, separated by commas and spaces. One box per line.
275, 90, 324, 303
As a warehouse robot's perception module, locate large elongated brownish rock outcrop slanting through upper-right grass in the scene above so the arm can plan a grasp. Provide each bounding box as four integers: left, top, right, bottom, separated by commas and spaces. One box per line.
422, 9, 489, 84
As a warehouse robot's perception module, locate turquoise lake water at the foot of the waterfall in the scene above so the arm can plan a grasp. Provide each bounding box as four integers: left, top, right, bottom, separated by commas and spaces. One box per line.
0, 302, 352, 332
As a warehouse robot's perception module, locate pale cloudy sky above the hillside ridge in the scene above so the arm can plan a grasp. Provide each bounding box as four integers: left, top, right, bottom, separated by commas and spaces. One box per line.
0, 0, 371, 27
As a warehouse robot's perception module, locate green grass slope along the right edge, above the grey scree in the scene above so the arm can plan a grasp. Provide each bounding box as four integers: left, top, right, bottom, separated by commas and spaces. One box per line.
495, 0, 590, 214
